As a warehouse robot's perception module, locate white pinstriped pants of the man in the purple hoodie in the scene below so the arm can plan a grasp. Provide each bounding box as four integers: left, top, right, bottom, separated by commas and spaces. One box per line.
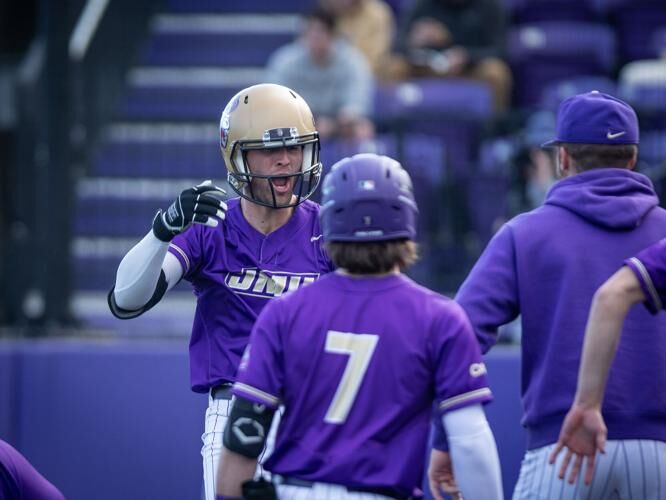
513, 439, 666, 500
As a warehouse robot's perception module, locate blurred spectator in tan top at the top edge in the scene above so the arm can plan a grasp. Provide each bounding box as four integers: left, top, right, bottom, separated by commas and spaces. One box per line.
321, 0, 395, 78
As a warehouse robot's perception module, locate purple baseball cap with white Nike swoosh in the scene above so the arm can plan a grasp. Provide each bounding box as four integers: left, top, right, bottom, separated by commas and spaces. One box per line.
541, 90, 638, 147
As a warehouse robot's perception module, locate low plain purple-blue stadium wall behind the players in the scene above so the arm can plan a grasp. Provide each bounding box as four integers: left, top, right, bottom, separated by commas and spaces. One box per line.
0, 339, 525, 500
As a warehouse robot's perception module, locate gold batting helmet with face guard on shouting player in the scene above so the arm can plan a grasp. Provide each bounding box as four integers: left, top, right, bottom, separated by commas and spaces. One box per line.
220, 84, 322, 208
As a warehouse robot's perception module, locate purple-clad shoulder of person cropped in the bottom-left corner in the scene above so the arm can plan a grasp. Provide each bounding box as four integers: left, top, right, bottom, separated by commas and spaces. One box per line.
0, 439, 65, 500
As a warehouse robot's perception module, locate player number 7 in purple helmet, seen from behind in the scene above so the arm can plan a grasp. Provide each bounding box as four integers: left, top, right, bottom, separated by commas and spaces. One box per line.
218, 154, 502, 500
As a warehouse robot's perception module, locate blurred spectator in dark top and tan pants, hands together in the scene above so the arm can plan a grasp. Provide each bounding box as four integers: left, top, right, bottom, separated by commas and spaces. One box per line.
391, 0, 512, 111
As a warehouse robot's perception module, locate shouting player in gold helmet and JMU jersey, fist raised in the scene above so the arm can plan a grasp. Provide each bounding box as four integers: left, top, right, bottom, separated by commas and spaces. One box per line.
109, 84, 332, 500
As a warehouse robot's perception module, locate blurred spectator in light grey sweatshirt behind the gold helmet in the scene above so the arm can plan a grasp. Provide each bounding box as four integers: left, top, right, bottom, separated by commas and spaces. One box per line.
266, 7, 374, 140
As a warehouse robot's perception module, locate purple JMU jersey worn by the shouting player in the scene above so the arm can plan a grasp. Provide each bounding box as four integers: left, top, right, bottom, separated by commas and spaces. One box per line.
169, 198, 333, 392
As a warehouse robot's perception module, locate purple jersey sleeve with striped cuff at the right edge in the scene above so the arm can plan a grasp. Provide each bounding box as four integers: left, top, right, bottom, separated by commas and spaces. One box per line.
624, 239, 666, 314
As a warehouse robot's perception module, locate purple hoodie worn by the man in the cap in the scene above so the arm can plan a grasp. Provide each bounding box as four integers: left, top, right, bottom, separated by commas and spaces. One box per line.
456, 168, 666, 449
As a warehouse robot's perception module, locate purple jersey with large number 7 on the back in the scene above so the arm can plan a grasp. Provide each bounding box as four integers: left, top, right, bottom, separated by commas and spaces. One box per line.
233, 273, 491, 494
